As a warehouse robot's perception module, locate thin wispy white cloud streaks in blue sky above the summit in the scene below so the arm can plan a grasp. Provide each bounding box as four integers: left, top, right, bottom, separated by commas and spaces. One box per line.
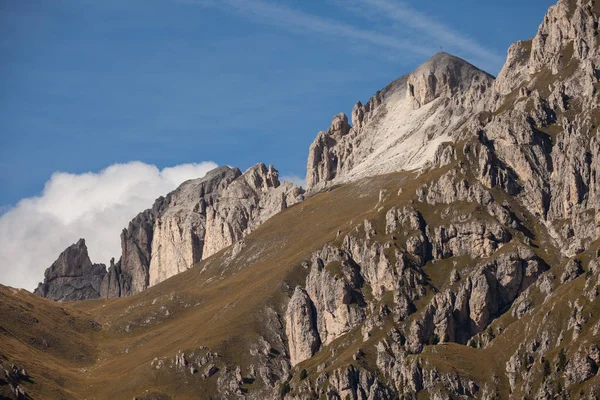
177, 0, 504, 71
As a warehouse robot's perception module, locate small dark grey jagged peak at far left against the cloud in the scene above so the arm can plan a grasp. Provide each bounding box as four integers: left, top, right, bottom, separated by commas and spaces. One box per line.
34, 239, 106, 301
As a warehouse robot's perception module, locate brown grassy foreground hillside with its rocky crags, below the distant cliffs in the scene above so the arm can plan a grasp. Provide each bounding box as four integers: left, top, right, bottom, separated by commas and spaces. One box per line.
0, 157, 600, 399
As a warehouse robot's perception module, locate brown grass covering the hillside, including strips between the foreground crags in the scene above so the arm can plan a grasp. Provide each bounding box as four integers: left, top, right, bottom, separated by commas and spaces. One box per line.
0, 153, 597, 399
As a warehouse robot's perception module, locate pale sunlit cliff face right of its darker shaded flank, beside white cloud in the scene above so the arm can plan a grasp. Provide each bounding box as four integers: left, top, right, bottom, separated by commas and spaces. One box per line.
149, 164, 303, 286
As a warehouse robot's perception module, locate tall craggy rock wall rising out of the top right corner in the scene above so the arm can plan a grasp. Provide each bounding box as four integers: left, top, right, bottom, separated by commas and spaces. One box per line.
474, 0, 600, 255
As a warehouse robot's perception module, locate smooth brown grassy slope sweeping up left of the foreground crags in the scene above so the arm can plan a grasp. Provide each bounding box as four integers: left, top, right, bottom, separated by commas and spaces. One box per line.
0, 175, 407, 399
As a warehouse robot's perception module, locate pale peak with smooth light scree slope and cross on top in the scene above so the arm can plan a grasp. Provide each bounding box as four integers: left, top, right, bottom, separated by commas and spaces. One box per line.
306, 53, 493, 192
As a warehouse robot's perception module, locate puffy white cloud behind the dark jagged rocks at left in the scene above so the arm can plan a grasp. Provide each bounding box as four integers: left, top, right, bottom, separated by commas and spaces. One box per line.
0, 162, 217, 290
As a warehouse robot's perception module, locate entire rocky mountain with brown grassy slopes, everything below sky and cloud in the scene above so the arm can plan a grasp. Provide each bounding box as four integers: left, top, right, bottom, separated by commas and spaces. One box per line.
0, 0, 600, 400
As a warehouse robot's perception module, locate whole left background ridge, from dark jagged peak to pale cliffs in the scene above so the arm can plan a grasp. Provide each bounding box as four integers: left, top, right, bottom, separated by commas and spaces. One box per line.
37, 164, 304, 299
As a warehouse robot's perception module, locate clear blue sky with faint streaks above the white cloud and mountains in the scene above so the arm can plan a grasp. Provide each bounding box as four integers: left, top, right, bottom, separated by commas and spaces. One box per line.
0, 0, 555, 206
